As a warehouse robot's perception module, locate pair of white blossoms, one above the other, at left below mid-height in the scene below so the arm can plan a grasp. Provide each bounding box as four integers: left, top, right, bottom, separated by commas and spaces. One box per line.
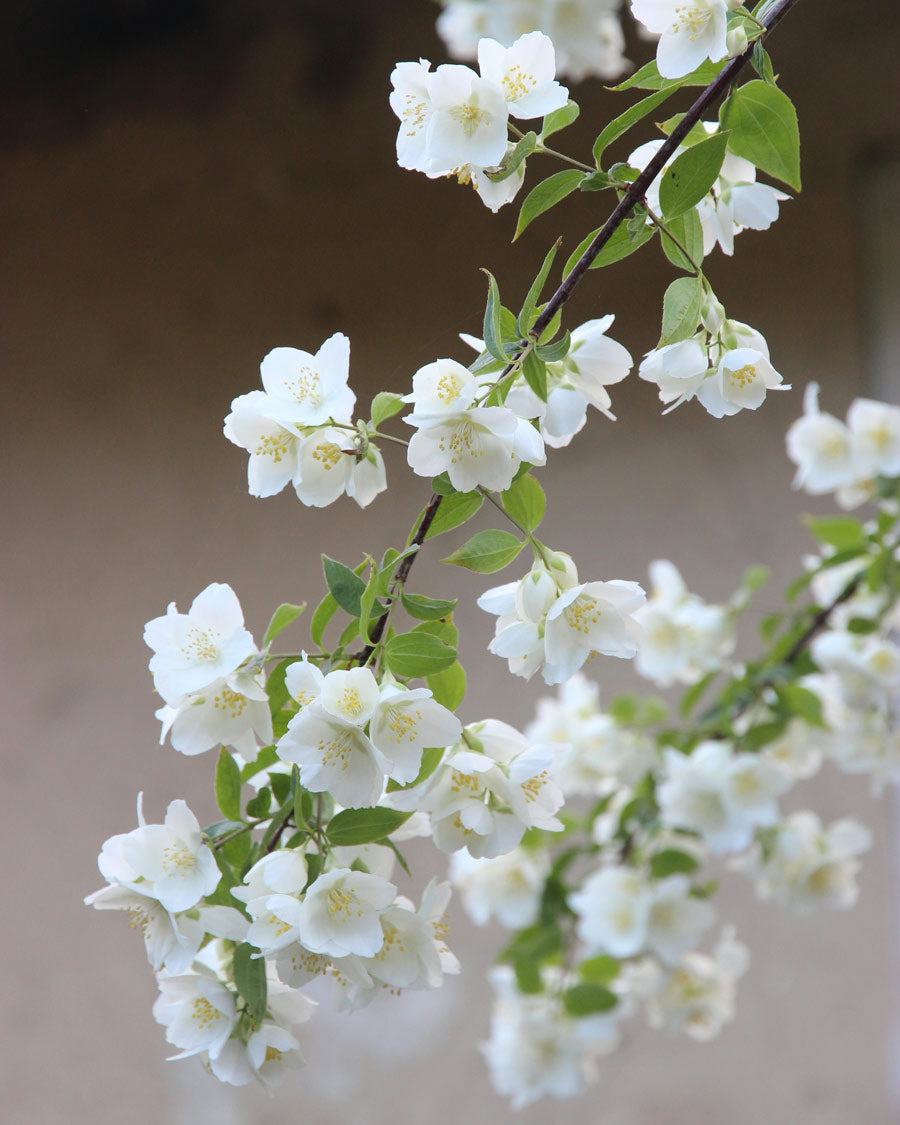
144, 582, 272, 757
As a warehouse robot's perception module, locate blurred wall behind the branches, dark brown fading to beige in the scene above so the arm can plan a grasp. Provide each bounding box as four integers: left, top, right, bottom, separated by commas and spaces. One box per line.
0, 0, 900, 1125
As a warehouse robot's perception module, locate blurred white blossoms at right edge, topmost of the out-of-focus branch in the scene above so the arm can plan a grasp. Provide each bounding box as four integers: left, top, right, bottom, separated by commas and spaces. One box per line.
788, 383, 900, 509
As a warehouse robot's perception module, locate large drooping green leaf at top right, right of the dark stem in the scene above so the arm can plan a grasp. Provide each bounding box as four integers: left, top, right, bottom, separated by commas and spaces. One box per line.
719, 79, 800, 191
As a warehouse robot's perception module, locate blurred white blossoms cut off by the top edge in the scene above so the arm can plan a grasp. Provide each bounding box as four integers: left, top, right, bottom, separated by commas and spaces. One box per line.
438, 0, 629, 82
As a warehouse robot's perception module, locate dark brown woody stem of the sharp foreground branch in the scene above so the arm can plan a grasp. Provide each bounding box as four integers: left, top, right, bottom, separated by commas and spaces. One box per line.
353, 0, 798, 664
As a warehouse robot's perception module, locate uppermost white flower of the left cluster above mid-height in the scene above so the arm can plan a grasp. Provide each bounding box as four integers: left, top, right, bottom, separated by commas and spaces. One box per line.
260, 332, 357, 428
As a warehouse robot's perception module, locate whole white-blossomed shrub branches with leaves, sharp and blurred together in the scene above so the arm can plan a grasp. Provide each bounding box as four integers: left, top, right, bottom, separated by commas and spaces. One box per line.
86, 0, 900, 1106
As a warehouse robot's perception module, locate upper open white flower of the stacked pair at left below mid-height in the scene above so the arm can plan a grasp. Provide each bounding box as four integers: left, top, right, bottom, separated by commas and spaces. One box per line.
144, 582, 257, 703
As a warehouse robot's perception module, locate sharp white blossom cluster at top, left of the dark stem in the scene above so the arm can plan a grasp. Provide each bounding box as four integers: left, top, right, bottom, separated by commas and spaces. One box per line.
390, 32, 568, 210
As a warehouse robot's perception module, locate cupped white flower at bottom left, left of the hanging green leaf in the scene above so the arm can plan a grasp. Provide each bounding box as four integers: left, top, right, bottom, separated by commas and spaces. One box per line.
153, 973, 236, 1060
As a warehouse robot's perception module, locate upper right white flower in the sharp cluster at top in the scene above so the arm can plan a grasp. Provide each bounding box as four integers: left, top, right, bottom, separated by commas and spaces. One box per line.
478, 32, 569, 117
